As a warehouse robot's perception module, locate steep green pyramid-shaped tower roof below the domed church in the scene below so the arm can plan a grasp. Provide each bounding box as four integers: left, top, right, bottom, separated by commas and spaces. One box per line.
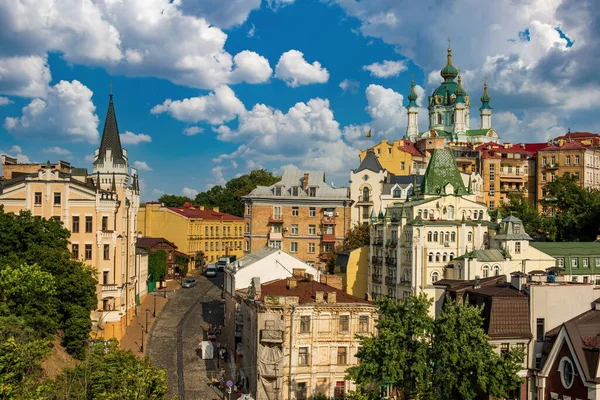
421, 149, 468, 196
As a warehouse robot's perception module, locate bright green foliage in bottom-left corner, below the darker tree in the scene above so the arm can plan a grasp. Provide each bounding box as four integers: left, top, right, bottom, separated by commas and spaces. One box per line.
0, 316, 51, 399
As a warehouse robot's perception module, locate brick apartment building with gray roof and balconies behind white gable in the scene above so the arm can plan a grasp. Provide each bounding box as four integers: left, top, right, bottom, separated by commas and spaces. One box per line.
244, 169, 352, 267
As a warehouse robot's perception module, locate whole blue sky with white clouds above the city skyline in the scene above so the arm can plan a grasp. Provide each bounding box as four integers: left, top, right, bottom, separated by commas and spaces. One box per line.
0, 0, 600, 200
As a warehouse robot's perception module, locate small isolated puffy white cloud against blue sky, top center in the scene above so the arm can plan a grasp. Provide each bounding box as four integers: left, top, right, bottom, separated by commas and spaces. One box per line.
275, 50, 329, 87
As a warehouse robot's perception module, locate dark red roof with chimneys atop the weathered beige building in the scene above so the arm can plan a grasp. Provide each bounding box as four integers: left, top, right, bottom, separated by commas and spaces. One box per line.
260, 279, 371, 304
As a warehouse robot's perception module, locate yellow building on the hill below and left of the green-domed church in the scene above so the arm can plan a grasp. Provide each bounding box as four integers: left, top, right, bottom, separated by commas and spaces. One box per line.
360, 139, 427, 176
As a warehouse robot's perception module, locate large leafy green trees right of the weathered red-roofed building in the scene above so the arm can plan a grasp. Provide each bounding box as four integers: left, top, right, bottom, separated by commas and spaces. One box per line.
347, 294, 523, 400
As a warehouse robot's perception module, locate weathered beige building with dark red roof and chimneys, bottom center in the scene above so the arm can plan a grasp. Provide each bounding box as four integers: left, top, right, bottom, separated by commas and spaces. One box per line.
238, 269, 377, 400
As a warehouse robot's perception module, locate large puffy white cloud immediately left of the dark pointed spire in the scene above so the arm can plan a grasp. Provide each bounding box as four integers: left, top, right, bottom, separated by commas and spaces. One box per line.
4, 80, 98, 143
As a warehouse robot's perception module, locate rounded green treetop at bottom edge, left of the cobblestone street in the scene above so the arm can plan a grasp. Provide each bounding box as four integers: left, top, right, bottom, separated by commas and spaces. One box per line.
44, 341, 168, 400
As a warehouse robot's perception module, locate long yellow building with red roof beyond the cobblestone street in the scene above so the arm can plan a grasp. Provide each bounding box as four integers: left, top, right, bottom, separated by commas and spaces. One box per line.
138, 202, 244, 269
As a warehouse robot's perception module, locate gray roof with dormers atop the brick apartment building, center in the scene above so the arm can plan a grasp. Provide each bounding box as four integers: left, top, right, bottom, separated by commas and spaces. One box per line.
246, 168, 349, 200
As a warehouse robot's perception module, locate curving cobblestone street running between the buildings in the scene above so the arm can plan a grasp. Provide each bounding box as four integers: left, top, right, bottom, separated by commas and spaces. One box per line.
146, 271, 230, 400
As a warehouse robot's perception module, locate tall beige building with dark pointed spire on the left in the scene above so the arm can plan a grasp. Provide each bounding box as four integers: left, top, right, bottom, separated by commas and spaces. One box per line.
0, 94, 142, 339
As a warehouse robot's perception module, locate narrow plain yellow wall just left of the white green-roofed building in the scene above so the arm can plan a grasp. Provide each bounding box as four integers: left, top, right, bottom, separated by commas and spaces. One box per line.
335, 246, 369, 298
